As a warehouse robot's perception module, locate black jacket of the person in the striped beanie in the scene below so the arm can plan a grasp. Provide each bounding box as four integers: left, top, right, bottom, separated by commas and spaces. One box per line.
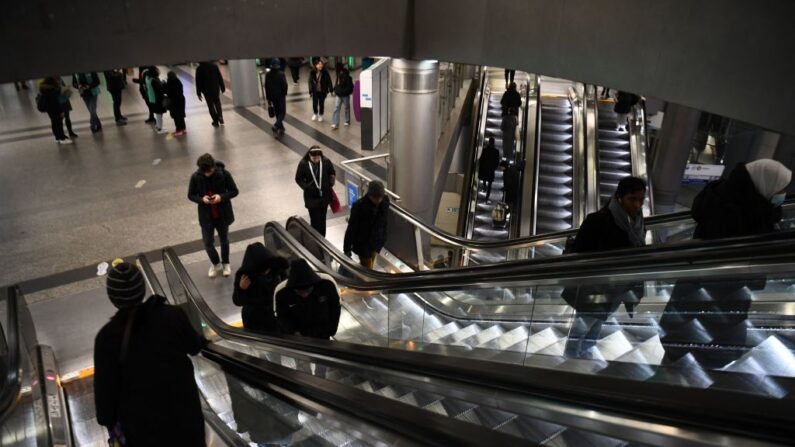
94, 296, 205, 446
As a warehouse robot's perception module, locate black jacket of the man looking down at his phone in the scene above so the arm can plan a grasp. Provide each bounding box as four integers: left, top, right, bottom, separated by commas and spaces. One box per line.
188, 161, 239, 227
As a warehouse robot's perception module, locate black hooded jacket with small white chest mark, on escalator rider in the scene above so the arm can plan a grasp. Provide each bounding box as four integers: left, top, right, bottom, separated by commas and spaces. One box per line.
275, 260, 341, 339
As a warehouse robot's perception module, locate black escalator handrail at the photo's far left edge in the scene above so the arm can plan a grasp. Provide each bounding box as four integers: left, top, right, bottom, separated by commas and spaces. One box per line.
0, 286, 22, 425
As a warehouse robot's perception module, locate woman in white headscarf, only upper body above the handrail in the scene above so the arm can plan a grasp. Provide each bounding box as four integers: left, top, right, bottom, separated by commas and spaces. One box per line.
692, 159, 792, 239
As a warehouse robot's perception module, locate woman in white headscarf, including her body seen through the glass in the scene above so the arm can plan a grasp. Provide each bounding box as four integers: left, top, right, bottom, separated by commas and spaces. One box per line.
660, 159, 792, 368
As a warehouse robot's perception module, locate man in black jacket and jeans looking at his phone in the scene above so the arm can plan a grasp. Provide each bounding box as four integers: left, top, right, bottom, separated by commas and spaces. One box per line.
188, 154, 239, 278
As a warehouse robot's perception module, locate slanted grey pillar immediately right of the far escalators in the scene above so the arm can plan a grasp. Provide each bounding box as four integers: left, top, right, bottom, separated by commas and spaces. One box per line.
651, 103, 701, 214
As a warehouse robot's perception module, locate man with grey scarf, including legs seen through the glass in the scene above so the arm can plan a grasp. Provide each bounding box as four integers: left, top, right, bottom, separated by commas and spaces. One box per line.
561, 177, 646, 359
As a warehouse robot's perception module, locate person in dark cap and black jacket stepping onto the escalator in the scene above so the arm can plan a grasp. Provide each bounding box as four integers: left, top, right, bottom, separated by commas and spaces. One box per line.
343, 181, 389, 270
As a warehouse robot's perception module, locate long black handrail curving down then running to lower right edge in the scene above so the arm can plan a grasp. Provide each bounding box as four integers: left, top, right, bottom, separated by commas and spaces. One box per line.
163, 248, 795, 442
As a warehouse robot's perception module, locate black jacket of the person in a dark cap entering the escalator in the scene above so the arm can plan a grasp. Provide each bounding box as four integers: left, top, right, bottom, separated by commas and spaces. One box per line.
343, 196, 389, 258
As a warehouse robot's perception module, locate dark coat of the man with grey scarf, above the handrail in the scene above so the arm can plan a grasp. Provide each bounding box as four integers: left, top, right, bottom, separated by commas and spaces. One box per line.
566, 207, 633, 253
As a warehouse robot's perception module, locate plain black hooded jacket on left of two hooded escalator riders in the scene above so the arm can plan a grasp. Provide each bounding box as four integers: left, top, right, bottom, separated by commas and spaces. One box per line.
232, 242, 287, 333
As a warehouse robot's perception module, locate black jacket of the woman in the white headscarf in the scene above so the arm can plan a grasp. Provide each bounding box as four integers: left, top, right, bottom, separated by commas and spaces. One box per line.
692, 163, 781, 239
